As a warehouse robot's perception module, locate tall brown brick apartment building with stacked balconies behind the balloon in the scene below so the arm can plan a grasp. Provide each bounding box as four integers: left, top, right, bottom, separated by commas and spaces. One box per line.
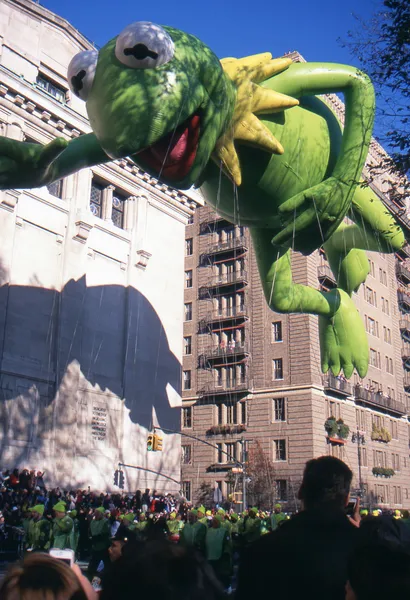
181, 97, 410, 508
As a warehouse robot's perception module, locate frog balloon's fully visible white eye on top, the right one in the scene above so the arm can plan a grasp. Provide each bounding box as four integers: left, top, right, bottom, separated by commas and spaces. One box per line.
115, 21, 174, 69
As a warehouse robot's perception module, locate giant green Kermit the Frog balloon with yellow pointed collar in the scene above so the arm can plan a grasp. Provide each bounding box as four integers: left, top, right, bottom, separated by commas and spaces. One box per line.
0, 21, 405, 377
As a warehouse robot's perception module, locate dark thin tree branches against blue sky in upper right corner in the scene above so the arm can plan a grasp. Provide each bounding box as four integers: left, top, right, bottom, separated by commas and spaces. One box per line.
342, 0, 410, 202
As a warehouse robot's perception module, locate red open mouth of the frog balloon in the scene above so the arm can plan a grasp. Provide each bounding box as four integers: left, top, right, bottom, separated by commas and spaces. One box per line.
136, 114, 200, 181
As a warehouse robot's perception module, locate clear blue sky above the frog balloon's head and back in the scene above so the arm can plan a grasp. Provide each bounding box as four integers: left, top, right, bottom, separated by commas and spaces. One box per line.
40, 0, 380, 64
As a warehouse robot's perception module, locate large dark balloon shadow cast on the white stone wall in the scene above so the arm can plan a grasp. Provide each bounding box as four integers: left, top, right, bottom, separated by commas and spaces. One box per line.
0, 265, 181, 468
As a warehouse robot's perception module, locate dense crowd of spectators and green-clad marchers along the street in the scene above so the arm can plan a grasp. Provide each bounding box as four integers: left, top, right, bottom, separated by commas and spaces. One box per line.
0, 457, 410, 600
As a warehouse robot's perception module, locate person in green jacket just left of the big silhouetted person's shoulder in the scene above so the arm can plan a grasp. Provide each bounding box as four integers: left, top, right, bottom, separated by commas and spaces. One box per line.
205, 512, 232, 588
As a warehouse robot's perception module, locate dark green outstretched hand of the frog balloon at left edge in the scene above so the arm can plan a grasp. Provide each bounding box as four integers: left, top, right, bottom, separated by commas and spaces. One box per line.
0, 137, 69, 190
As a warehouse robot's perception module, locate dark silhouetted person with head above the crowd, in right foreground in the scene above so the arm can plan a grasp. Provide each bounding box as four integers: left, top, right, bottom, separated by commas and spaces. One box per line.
236, 456, 359, 600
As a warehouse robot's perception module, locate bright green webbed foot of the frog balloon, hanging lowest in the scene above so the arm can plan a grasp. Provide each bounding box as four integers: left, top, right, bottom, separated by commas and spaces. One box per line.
319, 289, 369, 378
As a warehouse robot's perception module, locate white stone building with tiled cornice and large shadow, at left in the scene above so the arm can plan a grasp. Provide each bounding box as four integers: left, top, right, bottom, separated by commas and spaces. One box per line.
0, 0, 200, 491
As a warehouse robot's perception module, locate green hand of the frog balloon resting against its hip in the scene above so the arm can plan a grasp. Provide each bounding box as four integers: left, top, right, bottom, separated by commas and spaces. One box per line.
272, 177, 354, 246
